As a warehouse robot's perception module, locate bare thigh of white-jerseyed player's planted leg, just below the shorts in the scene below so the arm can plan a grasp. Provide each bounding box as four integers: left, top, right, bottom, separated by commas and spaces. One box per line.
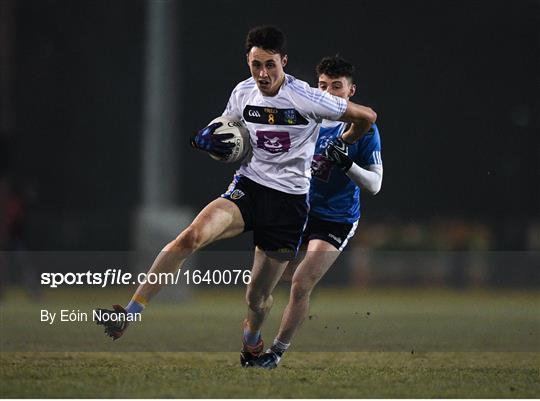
248, 247, 288, 295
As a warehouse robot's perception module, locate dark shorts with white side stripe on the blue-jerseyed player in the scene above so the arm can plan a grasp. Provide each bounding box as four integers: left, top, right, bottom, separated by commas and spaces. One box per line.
302, 214, 358, 251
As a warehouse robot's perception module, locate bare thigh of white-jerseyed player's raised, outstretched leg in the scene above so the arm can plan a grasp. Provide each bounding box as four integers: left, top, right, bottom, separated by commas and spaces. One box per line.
191, 198, 244, 246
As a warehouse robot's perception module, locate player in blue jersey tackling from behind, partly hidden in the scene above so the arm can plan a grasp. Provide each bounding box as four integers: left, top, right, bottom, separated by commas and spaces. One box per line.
257, 56, 383, 369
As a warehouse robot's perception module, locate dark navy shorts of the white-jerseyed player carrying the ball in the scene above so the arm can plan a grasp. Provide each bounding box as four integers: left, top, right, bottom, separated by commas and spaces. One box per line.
221, 175, 309, 260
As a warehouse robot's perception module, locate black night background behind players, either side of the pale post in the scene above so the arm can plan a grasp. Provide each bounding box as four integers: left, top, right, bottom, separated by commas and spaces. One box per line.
0, 0, 540, 250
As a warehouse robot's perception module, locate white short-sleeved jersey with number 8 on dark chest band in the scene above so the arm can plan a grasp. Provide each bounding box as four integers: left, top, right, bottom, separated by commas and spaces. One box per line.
223, 75, 347, 194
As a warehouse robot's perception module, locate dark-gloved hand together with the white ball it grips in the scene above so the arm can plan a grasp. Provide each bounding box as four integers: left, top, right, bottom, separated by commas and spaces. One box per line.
191, 117, 250, 163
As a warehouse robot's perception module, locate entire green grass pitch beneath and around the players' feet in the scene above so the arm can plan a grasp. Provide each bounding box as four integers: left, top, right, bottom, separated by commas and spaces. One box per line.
0, 289, 540, 398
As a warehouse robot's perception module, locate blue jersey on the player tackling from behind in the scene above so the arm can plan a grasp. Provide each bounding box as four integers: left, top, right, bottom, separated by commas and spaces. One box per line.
309, 120, 382, 223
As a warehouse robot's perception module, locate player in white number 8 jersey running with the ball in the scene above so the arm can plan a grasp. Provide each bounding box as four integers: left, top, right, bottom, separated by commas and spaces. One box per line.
98, 27, 377, 366
